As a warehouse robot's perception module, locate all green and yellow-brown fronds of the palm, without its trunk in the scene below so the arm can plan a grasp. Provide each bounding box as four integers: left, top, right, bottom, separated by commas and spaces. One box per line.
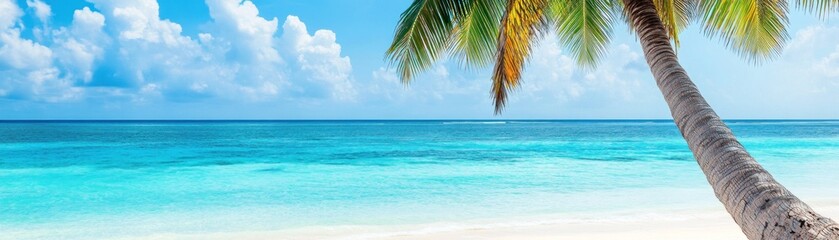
386, 0, 839, 113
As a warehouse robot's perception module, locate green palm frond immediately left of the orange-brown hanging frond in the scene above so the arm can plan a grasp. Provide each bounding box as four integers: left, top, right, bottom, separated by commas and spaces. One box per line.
452, 0, 506, 67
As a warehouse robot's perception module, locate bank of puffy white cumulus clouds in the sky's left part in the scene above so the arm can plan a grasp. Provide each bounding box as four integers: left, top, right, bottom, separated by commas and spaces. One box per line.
0, 0, 355, 103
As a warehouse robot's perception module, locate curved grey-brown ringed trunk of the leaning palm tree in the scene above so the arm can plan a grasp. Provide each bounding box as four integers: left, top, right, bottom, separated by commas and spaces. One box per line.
623, 0, 839, 239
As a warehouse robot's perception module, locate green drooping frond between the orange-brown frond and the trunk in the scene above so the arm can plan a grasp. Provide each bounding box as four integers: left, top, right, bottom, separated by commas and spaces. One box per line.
549, 0, 616, 67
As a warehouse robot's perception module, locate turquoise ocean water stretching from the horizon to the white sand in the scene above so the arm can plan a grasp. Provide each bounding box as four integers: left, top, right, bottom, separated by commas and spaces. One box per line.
0, 120, 839, 239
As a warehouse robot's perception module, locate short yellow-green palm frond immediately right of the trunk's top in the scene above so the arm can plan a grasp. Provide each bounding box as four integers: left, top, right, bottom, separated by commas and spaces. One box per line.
653, 0, 696, 48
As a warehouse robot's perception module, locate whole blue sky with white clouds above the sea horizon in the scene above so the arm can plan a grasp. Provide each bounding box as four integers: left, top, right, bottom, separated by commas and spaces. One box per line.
0, 0, 839, 119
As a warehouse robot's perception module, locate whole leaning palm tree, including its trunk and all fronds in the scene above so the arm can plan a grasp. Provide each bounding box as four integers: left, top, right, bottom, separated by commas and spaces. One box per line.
387, 0, 839, 239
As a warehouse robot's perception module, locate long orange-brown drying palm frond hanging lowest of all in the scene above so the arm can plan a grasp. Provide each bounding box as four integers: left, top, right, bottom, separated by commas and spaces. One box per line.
491, 0, 548, 114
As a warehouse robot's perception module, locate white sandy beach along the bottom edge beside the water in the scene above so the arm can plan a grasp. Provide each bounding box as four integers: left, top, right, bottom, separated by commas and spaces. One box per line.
130, 201, 839, 240
